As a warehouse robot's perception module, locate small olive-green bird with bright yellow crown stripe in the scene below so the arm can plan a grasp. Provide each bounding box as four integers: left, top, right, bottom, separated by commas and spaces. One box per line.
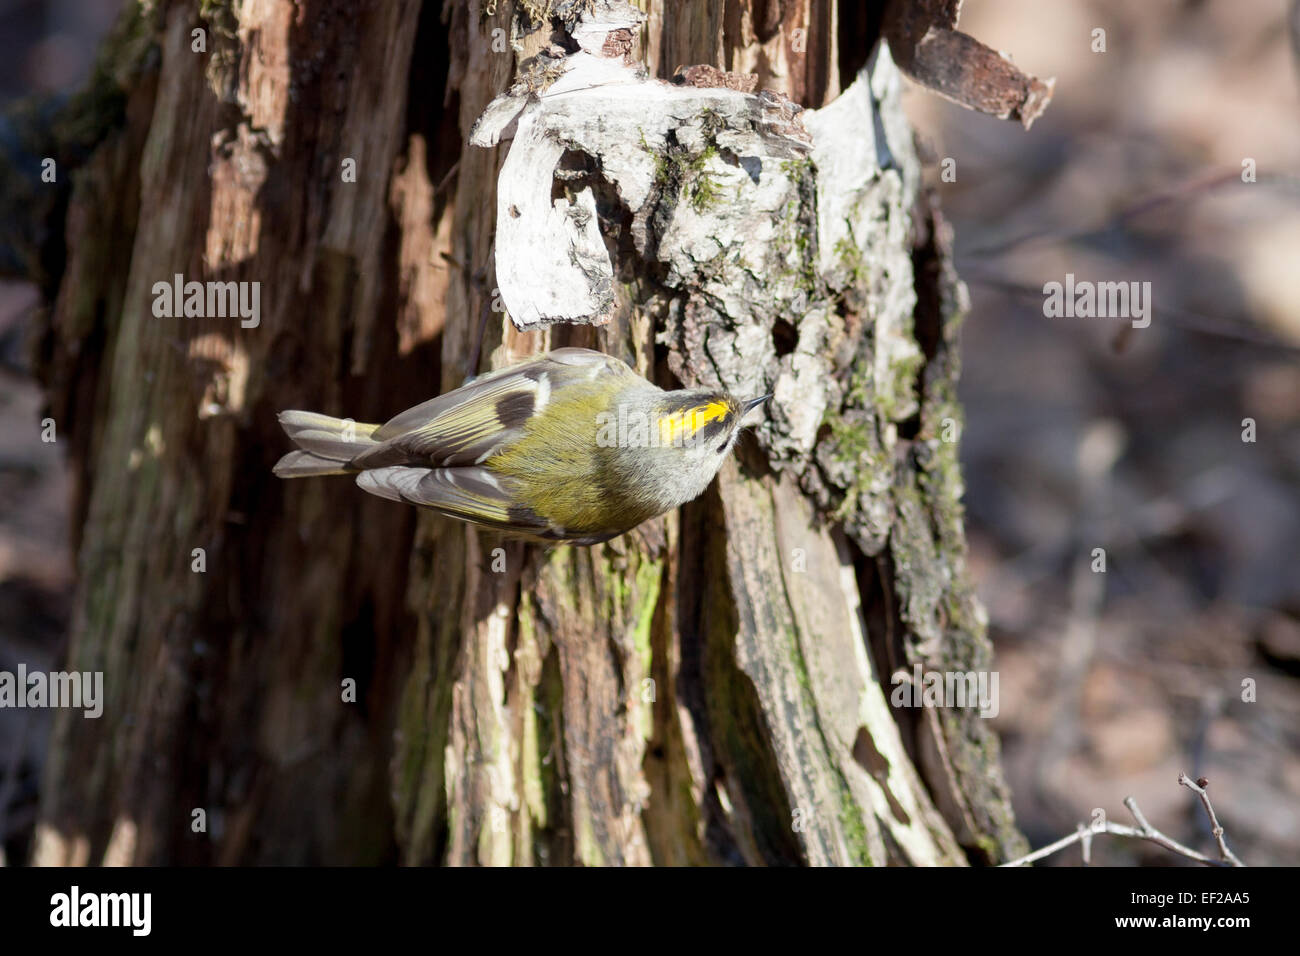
274, 349, 771, 545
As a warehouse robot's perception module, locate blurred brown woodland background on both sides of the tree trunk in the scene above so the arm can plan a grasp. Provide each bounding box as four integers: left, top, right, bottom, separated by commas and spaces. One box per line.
0, 0, 1300, 865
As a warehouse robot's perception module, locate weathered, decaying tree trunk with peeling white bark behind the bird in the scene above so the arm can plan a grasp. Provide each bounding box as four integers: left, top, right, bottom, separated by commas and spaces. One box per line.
12, 0, 1022, 865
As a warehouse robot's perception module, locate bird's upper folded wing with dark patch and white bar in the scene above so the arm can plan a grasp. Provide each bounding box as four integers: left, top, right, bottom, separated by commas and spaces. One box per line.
351, 349, 638, 468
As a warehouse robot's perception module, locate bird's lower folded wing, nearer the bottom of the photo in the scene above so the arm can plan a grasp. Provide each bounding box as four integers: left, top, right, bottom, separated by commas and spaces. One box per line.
356, 466, 550, 536
